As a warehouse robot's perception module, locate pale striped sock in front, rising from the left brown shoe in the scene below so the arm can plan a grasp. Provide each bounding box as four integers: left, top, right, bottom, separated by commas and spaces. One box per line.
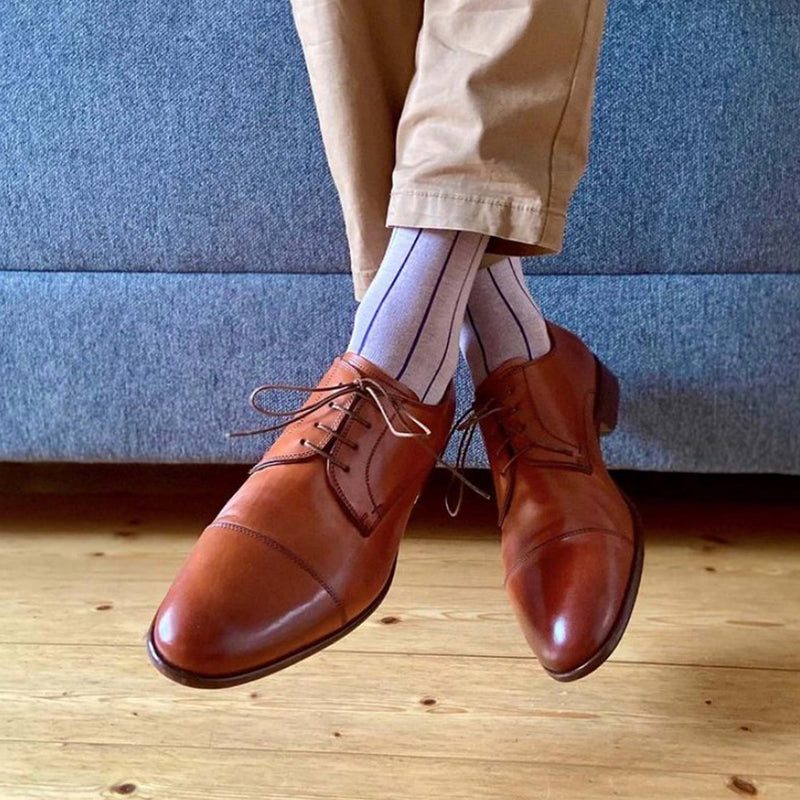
348, 226, 490, 403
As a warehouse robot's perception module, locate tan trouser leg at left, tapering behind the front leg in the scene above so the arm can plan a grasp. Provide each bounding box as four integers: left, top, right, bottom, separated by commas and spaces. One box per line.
292, 0, 423, 300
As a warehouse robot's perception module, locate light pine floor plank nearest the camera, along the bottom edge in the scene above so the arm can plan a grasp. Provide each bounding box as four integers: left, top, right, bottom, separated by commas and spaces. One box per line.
0, 742, 800, 800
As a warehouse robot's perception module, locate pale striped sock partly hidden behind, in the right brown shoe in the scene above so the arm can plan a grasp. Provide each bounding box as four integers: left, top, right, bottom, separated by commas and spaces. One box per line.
460, 253, 550, 386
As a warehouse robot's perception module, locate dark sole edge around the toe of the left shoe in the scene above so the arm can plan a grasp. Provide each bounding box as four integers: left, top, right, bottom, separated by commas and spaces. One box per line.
147, 558, 397, 689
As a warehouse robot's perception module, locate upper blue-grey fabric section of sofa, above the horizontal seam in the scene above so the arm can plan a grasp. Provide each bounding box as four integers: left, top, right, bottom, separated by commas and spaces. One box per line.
0, 0, 800, 274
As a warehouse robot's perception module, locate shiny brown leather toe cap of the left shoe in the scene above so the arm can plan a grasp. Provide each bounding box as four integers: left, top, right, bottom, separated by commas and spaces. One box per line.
151, 527, 342, 679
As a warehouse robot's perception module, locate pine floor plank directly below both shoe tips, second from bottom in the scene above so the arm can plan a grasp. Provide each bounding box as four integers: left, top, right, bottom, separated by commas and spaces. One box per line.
0, 645, 800, 777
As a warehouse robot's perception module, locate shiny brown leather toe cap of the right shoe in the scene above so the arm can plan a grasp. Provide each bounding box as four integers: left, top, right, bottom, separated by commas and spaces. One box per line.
507, 530, 634, 679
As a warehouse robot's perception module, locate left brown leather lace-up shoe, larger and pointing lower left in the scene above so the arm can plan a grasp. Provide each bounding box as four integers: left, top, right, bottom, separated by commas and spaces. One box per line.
147, 352, 455, 688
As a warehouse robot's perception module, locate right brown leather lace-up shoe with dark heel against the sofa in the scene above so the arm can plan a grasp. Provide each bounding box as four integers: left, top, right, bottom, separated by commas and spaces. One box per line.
459, 321, 644, 681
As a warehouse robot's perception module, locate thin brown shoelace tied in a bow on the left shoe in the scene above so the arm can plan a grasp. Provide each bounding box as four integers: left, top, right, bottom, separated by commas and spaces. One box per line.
226, 377, 489, 499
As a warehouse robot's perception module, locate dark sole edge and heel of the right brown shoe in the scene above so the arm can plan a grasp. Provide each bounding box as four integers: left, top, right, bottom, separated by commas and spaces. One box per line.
544, 356, 644, 682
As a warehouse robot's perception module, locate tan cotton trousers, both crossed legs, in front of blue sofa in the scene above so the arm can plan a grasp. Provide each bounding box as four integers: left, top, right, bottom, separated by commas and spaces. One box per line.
292, 0, 606, 300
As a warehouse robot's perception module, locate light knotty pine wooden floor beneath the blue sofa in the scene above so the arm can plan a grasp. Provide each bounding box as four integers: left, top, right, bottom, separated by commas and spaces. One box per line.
0, 465, 800, 800
